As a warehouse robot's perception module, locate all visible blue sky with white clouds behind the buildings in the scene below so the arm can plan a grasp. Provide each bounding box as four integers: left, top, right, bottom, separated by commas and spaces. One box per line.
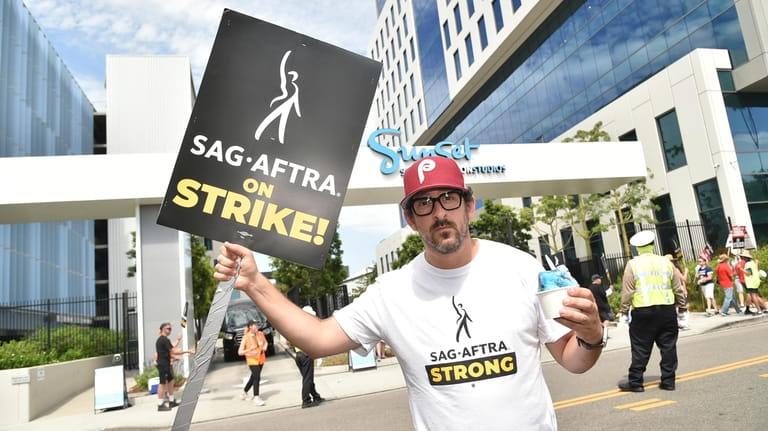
23, 0, 400, 274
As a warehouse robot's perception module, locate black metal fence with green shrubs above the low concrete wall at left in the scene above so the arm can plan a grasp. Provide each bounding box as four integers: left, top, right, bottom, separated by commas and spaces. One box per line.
0, 293, 139, 369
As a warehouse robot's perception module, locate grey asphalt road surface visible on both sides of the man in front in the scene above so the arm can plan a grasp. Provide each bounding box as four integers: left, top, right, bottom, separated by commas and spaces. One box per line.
191, 319, 768, 431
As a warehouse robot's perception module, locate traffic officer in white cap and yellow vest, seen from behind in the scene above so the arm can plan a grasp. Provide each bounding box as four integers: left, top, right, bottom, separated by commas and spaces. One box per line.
619, 231, 685, 392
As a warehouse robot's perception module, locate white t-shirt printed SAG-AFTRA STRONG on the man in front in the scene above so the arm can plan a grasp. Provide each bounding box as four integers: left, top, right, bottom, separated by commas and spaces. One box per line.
334, 240, 569, 431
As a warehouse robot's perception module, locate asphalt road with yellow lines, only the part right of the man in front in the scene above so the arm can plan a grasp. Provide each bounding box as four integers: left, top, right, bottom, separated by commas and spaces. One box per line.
545, 319, 768, 431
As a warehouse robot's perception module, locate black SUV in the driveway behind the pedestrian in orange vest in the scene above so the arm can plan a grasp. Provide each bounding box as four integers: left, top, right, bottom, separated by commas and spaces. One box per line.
221, 298, 275, 361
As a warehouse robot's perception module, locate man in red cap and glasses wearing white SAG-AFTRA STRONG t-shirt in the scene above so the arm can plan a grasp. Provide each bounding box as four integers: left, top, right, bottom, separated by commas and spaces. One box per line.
215, 156, 607, 431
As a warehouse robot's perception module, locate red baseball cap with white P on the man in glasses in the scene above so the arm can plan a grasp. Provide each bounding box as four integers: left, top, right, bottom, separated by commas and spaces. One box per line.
400, 156, 469, 208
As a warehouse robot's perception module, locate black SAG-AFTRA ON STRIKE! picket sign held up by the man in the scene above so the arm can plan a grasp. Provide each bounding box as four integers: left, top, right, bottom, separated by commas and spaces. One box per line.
158, 10, 381, 268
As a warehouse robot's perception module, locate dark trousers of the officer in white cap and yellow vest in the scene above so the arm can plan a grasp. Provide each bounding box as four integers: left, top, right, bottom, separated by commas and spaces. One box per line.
627, 305, 679, 387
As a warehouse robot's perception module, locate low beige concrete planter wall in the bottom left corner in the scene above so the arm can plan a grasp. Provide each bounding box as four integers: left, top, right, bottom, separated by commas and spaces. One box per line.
0, 355, 112, 426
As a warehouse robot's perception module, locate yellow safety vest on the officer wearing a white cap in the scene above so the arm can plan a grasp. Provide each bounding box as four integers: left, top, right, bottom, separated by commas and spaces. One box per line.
629, 253, 675, 308
